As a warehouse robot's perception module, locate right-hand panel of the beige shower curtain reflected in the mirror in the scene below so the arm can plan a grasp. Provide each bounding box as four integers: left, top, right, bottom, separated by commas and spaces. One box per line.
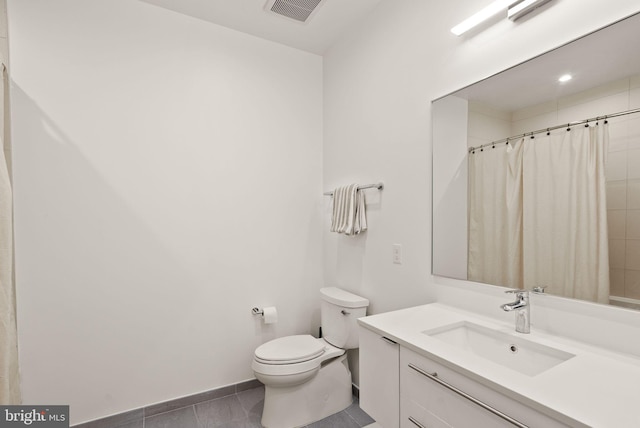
523, 124, 609, 303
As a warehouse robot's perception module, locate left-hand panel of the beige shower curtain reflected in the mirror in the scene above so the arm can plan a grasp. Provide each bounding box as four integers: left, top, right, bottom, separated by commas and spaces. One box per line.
467, 141, 523, 288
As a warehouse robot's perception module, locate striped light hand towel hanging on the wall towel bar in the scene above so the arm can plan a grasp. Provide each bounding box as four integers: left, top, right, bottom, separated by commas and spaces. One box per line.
330, 184, 367, 235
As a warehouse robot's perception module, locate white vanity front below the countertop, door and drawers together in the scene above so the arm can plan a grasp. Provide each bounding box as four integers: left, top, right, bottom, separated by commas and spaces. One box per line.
359, 326, 567, 428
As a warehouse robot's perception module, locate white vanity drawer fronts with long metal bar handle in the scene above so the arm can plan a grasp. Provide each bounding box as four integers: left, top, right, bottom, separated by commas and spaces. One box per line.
398, 347, 567, 428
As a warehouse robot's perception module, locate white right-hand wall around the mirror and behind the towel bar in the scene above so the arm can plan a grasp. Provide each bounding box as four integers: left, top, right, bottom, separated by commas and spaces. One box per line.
323, 0, 640, 332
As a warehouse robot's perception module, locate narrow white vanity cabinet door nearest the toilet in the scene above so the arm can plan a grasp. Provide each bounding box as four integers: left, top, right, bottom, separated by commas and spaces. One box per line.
359, 327, 400, 428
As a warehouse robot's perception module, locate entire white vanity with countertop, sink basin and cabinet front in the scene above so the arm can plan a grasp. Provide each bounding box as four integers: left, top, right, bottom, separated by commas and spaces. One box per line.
358, 303, 640, 428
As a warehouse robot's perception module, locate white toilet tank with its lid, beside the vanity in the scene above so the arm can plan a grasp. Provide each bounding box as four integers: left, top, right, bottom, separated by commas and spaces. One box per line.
320, 287, 369, 349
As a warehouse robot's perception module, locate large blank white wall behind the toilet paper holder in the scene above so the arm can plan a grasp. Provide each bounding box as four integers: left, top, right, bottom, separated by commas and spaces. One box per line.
8, 0, 324, 423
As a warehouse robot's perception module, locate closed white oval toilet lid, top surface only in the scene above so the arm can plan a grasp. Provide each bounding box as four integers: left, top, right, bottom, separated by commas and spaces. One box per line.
256, 334, 324, 364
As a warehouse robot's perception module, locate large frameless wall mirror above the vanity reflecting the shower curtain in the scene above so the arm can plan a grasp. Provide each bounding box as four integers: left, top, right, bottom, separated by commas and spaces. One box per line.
432, 10, 640, 309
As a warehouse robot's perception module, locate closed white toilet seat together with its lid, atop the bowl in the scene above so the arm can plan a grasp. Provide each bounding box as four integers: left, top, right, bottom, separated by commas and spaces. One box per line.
251, 335, 345, 376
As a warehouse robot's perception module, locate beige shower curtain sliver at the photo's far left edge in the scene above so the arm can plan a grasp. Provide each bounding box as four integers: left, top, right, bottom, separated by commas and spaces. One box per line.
0, 64, 21, 404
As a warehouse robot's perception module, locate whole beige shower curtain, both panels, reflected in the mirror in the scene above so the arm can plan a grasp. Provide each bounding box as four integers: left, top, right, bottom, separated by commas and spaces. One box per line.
468, 124, 609, 303
